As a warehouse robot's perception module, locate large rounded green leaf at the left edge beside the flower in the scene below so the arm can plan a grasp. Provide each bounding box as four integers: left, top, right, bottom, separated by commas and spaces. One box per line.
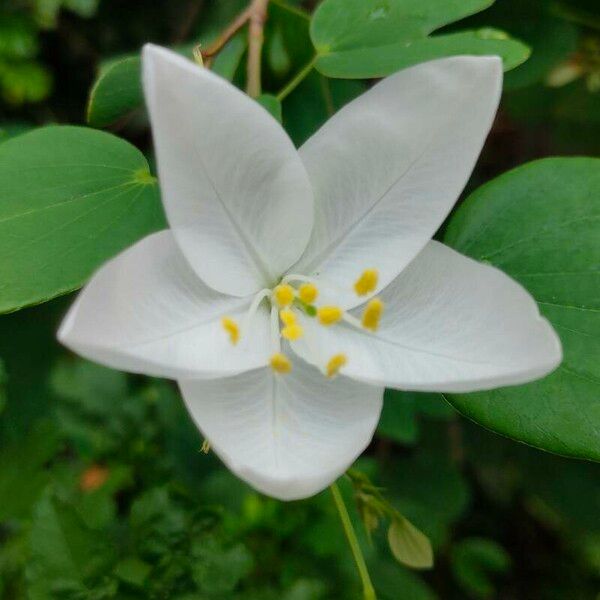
0, 126, 164, 313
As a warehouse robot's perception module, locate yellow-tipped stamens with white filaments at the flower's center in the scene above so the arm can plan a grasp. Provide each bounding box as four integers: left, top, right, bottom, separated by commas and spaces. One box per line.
221, 269, 384, 378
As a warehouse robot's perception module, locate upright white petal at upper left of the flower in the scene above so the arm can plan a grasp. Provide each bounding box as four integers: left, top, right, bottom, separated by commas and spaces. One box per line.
143, 45, 313, 296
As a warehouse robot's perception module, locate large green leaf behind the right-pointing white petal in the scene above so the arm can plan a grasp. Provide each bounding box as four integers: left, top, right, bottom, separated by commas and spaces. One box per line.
445, 158, 600, 460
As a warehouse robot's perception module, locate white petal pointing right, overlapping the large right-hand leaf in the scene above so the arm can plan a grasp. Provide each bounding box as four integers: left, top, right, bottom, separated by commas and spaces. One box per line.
293, 242, 561, 392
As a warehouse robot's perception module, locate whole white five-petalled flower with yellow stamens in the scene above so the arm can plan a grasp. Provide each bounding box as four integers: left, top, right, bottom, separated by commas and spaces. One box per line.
59, 46, 561, 499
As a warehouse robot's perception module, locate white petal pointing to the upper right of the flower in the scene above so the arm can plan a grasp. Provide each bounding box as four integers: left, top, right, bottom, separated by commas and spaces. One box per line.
292, 56, 502, 307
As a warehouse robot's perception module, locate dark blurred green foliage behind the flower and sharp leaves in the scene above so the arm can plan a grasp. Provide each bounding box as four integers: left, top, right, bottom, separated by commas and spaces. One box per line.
0, 0, 600, 600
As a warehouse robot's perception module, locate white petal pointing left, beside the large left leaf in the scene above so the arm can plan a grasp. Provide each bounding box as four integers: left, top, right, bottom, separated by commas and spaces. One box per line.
58, 231, 270, 379
